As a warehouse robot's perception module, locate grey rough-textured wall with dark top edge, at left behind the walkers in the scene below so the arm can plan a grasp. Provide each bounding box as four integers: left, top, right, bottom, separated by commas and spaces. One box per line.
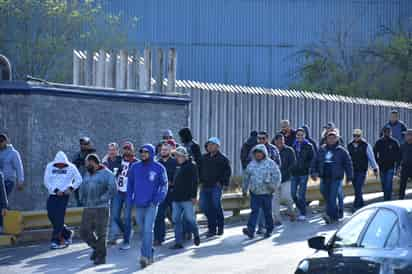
0, 83, 189, 209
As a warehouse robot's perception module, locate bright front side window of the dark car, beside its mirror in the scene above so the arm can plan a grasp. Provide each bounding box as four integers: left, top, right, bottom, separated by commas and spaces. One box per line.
333, 209, 376, 248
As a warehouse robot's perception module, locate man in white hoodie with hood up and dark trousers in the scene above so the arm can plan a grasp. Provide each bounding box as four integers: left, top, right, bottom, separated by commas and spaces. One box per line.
44, 151, 82, 249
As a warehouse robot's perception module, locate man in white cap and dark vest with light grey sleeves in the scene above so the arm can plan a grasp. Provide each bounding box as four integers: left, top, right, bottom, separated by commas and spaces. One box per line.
348, 129, 378, 211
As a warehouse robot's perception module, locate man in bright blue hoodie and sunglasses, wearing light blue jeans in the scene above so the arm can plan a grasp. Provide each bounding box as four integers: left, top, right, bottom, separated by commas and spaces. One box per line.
127, 144, 168, 268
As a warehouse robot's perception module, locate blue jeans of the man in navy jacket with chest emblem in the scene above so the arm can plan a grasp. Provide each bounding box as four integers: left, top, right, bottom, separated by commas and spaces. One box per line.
320, 179, 342, 220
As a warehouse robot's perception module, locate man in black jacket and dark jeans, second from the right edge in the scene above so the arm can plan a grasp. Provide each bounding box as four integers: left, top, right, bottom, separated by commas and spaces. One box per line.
373, 125, 400, 201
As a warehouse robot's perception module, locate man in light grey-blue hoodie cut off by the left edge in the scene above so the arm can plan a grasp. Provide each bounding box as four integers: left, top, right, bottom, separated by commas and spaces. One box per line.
0, 133, 24, 229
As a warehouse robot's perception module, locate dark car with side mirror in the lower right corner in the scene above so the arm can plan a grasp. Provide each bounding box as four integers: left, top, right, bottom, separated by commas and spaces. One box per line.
295, 200, 412, 274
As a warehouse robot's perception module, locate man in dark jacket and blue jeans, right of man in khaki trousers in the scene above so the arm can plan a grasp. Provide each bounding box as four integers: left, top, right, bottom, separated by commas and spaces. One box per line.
291, 128, 315, 221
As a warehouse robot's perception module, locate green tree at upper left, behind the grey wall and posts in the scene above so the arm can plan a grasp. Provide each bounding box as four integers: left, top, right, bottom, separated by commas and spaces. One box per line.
0, 0, 137, 82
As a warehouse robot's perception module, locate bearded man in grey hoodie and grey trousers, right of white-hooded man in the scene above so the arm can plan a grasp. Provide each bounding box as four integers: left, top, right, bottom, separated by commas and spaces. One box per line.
80, 154, 116, 265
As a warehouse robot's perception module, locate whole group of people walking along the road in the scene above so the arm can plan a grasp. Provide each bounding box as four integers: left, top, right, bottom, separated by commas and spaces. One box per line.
0, 108, 412, 267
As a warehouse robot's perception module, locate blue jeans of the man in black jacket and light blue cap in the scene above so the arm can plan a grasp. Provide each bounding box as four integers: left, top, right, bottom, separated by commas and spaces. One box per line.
200, 186, 224, 233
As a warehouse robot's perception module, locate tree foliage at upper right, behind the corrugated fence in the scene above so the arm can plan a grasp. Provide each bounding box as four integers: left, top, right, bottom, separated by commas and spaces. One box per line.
293, 19, 412, 101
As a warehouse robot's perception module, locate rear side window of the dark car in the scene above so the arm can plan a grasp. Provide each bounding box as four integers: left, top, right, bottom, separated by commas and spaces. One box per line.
361, 209, 398, 248
